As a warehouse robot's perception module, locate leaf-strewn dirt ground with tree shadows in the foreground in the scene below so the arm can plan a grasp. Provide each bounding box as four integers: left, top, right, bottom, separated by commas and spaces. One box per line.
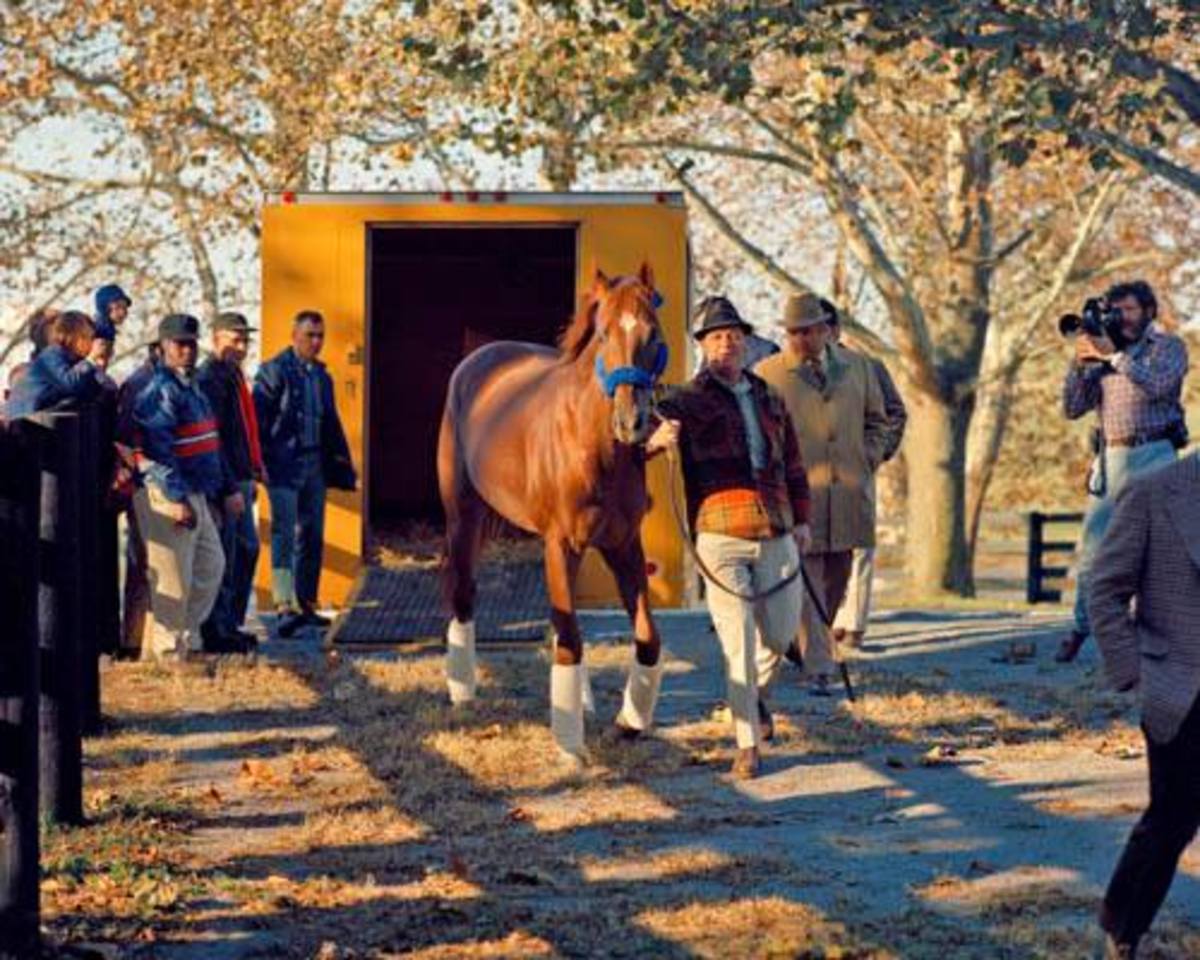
44, 612, 1200, 960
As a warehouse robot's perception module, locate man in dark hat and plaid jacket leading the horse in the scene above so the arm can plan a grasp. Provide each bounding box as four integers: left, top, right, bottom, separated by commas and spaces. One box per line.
646, 296, 811, 780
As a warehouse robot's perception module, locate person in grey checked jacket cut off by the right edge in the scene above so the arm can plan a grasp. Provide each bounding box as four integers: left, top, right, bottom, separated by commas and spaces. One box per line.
1087, 454, 1200, 958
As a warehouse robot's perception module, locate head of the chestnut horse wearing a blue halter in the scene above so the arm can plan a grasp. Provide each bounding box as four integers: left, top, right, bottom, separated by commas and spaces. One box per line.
589, 263, 667, 444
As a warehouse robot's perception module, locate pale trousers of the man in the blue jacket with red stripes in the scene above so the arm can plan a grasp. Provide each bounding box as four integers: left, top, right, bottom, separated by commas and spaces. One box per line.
133, 484, 224, 656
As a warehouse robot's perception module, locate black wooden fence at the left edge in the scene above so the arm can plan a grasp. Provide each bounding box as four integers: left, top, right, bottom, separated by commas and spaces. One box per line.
0, 407, 118, 956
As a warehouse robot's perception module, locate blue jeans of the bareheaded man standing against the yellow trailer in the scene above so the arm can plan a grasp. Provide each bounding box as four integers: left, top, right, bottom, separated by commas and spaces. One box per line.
266, 454, 325, 607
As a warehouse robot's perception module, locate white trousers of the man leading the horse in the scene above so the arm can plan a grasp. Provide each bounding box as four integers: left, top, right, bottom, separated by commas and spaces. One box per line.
696, 533, 804, 748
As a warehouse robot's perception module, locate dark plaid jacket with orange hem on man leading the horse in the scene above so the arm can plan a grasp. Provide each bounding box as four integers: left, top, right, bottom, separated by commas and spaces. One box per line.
658, 371, 809, 540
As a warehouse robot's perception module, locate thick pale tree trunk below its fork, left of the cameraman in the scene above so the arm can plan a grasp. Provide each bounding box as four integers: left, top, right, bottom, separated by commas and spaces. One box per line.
905, 391, 974, 596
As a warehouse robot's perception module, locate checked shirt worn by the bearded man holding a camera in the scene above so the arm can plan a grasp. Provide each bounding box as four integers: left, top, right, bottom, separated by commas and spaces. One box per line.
1062, 328, 1188, 443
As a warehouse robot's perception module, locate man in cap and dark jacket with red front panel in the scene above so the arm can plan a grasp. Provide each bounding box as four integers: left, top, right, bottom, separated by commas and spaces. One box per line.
197, 313, 266, 650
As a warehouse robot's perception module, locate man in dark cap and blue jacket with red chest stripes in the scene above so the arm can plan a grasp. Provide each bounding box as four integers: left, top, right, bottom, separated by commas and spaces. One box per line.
133, 313, 229, 660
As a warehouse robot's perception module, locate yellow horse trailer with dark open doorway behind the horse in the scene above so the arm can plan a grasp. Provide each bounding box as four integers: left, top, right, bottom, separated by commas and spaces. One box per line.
259, 192, 690, 633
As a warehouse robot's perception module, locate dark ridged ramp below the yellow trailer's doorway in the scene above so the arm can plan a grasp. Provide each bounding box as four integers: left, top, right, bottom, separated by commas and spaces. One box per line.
328, 559, 550, 647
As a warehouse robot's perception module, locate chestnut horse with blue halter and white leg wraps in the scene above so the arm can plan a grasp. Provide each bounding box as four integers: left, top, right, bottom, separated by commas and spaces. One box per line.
438, 264, 667, 761
